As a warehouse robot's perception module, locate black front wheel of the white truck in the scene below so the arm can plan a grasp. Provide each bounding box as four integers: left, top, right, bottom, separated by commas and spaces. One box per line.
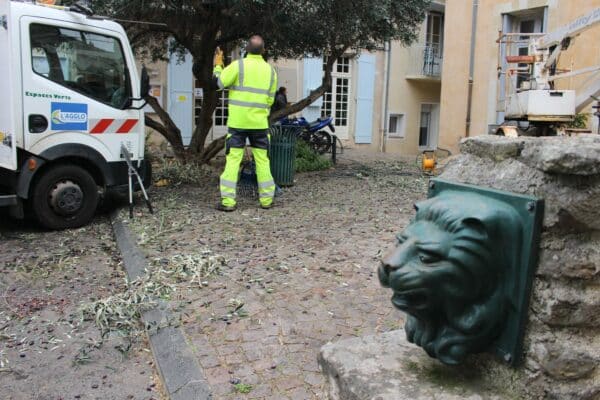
31, 165, 98, 229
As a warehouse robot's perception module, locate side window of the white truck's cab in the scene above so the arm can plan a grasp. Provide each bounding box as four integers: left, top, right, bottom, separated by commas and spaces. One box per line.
30, 24, 131, 109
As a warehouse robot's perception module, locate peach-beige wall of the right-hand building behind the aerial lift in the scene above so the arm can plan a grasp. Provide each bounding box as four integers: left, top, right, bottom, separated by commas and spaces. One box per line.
440, 0, 600, 150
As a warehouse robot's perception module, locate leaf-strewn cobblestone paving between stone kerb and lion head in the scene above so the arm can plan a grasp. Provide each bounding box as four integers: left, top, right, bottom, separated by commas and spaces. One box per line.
132, 152, 427, 400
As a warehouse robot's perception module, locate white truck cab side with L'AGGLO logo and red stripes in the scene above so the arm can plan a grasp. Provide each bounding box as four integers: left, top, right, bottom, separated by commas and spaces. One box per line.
21, 17, 144, 162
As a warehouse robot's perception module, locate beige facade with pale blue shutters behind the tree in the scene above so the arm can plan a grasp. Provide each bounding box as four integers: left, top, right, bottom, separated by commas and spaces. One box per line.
147, 0, 444, 154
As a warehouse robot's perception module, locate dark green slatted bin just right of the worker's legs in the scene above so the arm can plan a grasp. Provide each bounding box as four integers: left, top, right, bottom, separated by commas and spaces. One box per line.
269, 125, 299, 186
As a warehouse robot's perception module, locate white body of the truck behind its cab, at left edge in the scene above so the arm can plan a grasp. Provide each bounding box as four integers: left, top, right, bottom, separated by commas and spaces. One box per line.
0, 1, 17, 170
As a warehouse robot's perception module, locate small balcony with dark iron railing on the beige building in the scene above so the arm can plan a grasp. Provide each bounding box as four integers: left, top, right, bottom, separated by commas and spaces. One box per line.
406, 45, 443, 82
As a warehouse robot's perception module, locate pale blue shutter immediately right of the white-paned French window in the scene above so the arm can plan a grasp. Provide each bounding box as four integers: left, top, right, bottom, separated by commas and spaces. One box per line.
354, 53, 375, 143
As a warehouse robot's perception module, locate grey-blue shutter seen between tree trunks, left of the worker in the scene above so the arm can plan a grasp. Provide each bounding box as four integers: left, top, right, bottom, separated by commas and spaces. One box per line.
167, 50, 194, 146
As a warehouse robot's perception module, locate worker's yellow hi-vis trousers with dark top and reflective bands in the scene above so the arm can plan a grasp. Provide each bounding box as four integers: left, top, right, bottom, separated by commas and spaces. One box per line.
220, 128, 275, 207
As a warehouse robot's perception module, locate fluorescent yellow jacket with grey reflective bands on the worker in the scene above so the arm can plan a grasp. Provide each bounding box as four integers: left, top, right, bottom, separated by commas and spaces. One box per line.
213, 54, 277, 129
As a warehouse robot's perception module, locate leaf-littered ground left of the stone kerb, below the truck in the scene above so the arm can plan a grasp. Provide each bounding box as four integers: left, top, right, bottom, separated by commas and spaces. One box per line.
0, 215, 161, 400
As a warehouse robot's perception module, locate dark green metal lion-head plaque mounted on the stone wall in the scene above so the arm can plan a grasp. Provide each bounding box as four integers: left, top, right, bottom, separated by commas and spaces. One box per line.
379, 179, 544, 366
